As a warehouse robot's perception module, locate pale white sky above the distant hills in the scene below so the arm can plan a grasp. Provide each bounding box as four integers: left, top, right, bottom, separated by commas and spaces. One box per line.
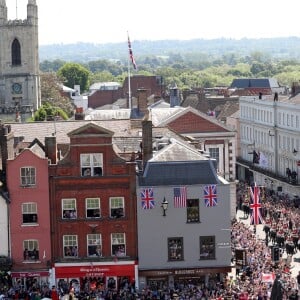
6, 0, 300, 45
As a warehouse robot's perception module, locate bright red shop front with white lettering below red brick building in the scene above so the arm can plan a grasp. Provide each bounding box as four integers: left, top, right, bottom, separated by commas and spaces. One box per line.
54, 261, 137, 291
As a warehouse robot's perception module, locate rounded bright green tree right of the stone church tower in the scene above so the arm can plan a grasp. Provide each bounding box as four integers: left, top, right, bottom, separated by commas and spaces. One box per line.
57, 63, 91, 91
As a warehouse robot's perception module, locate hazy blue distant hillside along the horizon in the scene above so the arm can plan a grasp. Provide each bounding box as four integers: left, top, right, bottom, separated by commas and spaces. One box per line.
39, 37, 300, 63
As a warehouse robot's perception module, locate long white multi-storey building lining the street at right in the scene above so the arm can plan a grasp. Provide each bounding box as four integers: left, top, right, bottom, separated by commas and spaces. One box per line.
237, 95, 300, 195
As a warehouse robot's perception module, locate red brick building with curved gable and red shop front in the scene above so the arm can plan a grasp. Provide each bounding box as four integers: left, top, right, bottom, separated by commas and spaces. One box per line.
47, 123, 137, 287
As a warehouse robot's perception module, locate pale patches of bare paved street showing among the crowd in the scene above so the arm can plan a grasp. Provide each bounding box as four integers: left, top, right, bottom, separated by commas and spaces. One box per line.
230, 210, 300, 278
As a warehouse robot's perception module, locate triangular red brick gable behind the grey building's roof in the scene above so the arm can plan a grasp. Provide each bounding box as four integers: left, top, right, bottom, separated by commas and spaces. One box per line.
167, 111, 228, 134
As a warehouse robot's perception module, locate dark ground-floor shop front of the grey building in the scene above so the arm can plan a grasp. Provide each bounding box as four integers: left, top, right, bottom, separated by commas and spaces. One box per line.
139, 267, 231, 290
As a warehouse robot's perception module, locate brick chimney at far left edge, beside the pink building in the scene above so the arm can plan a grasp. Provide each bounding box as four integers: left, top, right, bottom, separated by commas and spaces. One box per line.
0, 123, 15, 174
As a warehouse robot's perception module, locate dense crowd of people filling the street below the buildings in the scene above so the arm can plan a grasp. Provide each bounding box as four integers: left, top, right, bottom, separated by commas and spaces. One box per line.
0, 183, 300, 300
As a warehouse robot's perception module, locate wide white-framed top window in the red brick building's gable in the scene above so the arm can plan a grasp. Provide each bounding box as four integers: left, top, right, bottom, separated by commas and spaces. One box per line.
80, 153, 103, 177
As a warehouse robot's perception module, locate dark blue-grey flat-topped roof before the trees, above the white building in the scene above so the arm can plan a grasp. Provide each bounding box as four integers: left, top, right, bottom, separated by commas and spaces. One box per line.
230, 78, 279, 88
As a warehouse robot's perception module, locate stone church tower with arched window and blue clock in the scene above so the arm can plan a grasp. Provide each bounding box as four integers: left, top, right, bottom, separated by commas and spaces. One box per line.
0, 0, 41, 116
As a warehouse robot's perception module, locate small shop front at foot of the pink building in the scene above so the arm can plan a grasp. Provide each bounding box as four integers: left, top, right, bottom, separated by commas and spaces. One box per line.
10, 270, 49, 290
